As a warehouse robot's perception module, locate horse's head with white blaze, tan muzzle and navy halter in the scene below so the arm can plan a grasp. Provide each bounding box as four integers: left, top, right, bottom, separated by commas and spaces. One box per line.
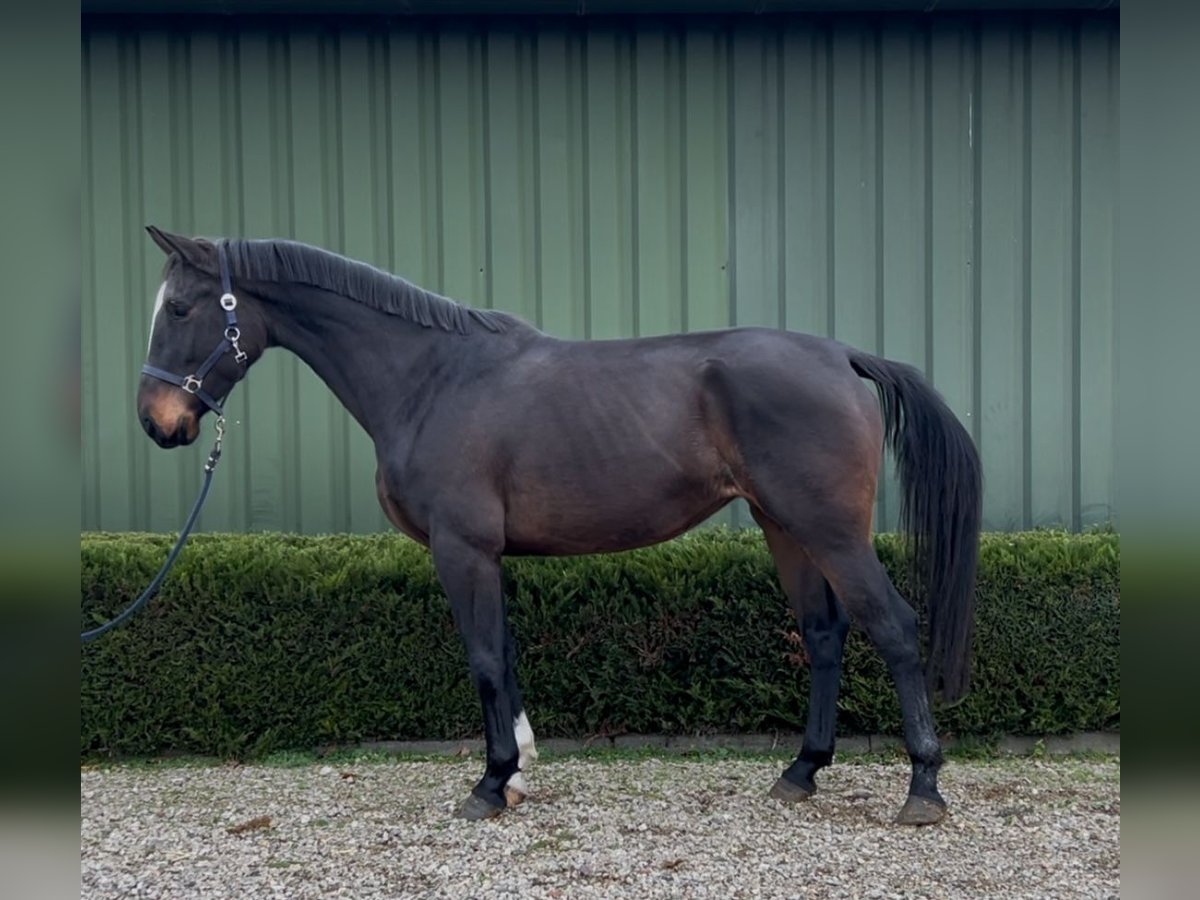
137, 226, 266, 448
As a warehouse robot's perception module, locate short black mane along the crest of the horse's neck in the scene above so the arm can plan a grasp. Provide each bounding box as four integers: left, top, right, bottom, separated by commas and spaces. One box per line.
226, 239, 520, 334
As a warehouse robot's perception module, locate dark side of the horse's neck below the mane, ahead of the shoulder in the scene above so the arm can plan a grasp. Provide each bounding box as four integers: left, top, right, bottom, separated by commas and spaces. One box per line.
268, 289, 450, 439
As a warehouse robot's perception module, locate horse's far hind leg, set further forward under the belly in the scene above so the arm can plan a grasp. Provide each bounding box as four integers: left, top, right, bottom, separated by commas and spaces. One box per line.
752, 510, 850, 802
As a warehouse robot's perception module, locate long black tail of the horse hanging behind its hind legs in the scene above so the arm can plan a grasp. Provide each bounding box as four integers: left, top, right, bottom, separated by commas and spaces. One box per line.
850, 349, 983, 702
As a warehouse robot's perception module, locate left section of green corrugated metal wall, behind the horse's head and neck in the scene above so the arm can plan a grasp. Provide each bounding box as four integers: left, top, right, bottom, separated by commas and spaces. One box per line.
83, 22, 728, 532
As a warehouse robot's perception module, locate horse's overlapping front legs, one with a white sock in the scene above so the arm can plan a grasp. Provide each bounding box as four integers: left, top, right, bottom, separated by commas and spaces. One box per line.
430, 528, 535, 820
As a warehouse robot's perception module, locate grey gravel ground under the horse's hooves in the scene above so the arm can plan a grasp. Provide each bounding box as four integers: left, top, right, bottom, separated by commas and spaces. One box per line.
79, 754, 1121, 900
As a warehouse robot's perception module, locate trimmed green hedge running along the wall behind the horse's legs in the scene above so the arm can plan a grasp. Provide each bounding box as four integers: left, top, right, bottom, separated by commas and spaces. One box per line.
80, 529, 1121, 758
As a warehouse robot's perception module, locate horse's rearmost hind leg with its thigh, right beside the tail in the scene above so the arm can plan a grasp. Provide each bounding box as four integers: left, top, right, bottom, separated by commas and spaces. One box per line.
708, 362, 946, 824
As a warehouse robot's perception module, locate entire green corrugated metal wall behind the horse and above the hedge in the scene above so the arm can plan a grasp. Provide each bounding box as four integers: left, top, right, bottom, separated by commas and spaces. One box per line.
82, 16, 1118, 532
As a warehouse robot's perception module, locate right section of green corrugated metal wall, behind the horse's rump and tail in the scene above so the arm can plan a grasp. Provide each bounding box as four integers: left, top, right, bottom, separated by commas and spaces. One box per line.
731, 18, 1118, 529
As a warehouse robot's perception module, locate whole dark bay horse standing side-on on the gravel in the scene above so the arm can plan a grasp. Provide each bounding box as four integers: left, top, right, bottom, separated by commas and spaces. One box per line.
137, 227, 982, 824
